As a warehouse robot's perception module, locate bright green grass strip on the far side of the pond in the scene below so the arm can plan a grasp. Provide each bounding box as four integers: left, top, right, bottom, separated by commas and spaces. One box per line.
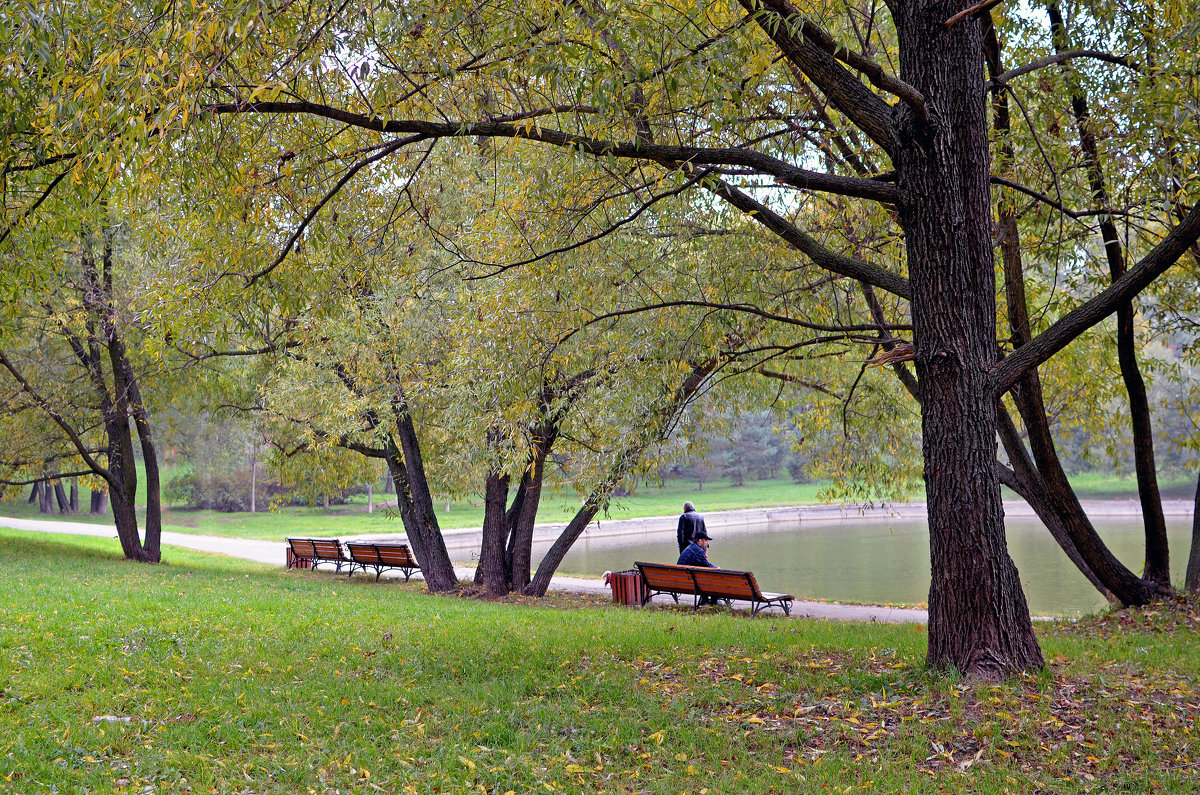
0, 473, 1195, 540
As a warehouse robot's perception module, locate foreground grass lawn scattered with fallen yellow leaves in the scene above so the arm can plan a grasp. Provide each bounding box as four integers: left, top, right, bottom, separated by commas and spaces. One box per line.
0, 530, 1200, 795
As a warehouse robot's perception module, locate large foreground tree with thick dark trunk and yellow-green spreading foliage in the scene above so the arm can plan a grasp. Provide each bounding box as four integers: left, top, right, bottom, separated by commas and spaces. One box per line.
14, 0, 1200, 676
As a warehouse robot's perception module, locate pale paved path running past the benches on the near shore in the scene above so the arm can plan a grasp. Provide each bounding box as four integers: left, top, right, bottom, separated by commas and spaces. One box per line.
0, 516, 929, 623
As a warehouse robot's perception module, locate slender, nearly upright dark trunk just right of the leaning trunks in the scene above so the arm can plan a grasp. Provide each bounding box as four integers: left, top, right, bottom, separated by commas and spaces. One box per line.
1046, 2, 1171, 590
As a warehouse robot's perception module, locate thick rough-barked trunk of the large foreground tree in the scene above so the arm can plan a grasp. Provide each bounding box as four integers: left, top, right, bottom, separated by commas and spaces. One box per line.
892, 1, 1043, 679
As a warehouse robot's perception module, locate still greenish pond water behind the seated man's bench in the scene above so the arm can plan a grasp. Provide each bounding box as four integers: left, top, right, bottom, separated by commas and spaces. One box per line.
535, 516, 1190, 615
